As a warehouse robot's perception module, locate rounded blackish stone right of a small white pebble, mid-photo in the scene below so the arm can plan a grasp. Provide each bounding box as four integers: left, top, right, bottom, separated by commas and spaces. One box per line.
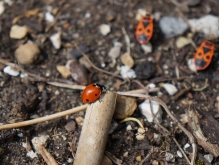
134, 61, 156, 79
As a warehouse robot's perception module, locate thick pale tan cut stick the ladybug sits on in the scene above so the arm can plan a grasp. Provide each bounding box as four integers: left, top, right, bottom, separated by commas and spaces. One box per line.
74, 91, 117, 165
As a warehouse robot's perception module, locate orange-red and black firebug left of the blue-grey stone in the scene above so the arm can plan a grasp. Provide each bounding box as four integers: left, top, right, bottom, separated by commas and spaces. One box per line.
135, 15, 154, 44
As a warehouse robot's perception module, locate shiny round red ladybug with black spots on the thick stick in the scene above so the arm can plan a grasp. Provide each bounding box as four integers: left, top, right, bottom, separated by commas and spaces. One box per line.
81, 83, 106, 103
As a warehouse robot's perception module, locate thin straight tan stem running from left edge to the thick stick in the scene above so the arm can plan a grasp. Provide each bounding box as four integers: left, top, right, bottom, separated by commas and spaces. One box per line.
0, 104, 87, 130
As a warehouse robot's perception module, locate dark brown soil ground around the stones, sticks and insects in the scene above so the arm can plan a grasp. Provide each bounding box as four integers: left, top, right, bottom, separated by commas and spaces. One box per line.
0, 0, 219, 165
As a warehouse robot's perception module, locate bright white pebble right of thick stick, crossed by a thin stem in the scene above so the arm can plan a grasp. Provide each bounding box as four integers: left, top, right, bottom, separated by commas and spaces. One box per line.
139, 100, 163, 123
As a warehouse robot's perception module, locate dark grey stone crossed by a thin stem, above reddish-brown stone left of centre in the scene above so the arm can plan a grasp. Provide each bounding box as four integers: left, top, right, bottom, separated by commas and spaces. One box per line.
67, 44, 90, 60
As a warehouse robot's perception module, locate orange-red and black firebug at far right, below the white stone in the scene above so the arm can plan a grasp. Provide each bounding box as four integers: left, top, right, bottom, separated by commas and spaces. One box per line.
194, 40, 214, 70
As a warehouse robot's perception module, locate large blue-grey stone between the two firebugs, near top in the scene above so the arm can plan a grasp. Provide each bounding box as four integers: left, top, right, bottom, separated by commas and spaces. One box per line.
159, 16, 188, 38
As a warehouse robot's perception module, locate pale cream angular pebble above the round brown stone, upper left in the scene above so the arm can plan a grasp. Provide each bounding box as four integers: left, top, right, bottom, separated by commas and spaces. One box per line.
10, 25, 28, 39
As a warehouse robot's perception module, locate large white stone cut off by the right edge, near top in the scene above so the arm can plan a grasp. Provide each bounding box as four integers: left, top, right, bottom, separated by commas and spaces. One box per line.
189, 14, 219, 39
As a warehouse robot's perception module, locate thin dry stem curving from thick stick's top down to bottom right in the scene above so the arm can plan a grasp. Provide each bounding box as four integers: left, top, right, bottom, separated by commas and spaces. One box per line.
116, 92, 197, 165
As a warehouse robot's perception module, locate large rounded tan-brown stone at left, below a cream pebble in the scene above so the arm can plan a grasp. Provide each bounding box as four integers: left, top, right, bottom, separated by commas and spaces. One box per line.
15, 42, 40, 65
